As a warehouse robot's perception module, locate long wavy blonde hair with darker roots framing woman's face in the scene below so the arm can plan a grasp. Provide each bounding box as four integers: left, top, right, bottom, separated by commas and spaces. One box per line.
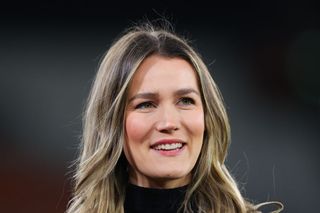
67, 20, 281, 213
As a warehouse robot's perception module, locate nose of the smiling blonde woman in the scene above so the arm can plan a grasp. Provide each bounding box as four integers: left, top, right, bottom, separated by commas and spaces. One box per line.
156, 106, 179, 133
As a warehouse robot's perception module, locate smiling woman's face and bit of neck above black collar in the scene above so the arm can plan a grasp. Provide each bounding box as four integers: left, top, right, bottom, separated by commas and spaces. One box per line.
124, 55, 204, 188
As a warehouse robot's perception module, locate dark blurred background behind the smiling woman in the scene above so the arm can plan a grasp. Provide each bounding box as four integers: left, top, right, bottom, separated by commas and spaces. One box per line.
0, 0, 320, 213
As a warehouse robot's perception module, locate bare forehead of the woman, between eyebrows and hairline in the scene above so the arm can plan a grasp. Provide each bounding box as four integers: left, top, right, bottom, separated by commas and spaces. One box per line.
129, 55, 199, 94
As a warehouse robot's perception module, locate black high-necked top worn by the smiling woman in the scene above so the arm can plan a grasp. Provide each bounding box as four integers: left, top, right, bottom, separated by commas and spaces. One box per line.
124, 184, 187, 213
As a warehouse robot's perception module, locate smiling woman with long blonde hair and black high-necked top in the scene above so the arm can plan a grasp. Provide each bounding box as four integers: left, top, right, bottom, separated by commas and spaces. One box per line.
67, 20, 280, 213
